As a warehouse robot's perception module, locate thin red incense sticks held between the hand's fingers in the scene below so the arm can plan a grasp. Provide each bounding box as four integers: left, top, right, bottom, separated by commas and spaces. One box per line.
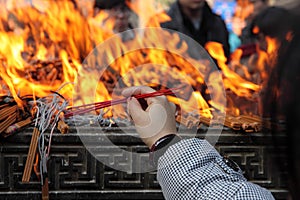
64, 88, 180, 118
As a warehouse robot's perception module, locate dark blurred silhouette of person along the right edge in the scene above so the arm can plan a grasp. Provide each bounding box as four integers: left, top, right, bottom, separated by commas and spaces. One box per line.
265, 24, 300, 200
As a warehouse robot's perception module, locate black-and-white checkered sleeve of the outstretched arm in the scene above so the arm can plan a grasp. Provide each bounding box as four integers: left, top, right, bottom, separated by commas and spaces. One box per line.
157, 138, 274, 200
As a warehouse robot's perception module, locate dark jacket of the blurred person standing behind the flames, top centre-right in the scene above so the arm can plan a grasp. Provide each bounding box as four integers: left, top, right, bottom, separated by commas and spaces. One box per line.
161, 1, 230, 58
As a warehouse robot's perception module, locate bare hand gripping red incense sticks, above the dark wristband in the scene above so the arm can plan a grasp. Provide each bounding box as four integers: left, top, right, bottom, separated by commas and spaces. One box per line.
122, 86, 176, 148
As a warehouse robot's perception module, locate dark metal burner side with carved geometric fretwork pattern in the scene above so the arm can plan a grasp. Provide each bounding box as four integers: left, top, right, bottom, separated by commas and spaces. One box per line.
0, 128, 287, 200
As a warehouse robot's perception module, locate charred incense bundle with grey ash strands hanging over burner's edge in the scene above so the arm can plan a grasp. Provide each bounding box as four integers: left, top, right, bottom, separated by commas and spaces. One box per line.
22, 85, 68, 199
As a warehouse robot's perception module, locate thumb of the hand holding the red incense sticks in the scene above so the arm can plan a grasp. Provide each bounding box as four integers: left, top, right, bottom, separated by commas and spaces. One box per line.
127, 97, 149, 125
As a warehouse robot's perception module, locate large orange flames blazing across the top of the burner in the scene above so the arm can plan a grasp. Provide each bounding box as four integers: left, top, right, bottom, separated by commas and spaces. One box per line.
0, 0, 278, 120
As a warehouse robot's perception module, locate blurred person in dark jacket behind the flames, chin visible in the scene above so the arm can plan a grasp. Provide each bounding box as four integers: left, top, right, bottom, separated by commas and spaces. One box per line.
161, 0, 230, 61
